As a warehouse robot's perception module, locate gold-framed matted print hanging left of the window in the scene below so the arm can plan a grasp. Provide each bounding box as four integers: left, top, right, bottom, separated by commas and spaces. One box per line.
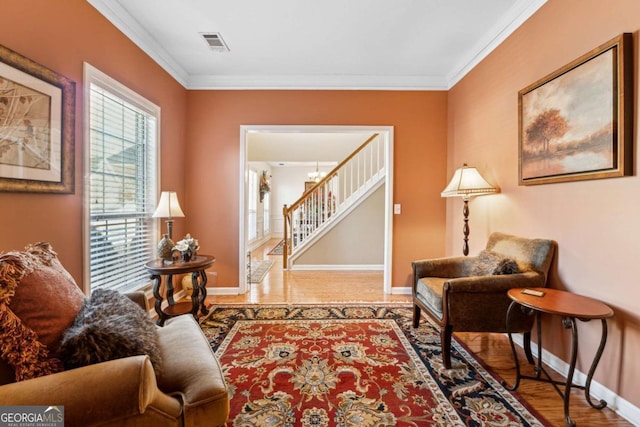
0, 45, 75, 194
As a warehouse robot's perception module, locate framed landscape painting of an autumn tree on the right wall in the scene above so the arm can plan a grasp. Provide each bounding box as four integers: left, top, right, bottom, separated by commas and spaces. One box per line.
518, 33, 633, 185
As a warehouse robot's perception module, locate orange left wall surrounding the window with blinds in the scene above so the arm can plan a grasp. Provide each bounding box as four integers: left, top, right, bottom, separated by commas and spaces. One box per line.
0, 0, 189, 284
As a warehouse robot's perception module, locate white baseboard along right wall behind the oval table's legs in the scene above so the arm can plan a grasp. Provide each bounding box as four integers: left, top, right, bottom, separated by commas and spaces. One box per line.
513, 334, 640, 425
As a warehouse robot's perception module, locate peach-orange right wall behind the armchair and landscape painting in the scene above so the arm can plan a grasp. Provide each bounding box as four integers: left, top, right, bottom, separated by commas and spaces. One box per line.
447, 0, 640, 407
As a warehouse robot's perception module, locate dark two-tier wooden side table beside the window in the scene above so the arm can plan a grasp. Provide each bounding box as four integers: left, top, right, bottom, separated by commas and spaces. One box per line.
144, 255, 216, 326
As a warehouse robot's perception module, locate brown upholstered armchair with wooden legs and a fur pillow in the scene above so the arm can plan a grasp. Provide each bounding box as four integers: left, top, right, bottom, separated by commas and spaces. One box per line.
412, 233, 555, 369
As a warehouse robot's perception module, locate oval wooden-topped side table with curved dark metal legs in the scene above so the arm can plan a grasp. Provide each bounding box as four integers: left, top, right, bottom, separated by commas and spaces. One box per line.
506, 288, 613, 427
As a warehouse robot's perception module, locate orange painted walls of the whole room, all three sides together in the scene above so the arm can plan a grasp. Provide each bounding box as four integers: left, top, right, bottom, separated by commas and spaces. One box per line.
0, 0, 640, 418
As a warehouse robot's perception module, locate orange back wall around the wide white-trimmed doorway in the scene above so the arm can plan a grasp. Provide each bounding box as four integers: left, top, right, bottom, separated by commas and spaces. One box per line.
185, 91, 447, 290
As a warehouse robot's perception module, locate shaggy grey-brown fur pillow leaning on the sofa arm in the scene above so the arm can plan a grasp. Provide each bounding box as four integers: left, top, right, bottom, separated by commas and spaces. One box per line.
58, 289, 160, 373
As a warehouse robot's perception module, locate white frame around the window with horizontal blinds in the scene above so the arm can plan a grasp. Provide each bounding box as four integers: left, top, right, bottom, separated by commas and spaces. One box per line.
82, 62, 162, 295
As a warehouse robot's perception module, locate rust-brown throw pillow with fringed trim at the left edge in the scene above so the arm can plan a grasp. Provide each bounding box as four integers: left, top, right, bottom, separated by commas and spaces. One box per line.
0, 242, 84, 381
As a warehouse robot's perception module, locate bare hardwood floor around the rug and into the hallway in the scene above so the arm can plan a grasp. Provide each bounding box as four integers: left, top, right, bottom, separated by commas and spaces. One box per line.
207, 239, 632, 427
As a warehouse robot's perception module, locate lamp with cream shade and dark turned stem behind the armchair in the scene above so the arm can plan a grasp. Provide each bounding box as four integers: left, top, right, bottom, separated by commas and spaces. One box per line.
440, 163, 497, 256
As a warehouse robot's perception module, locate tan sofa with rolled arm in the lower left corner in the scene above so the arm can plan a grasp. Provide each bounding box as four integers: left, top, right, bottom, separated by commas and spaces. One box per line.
0, 244, 229, 427
